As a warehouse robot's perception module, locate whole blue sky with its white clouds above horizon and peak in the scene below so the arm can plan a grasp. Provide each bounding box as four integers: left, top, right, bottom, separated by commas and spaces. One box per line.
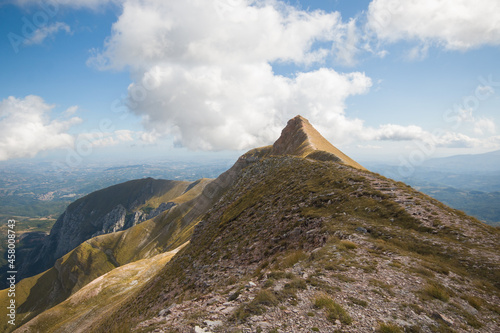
0, 0, 500, 168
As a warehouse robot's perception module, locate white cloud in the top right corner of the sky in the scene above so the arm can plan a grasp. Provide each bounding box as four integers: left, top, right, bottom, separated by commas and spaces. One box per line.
367, 0, 500, 50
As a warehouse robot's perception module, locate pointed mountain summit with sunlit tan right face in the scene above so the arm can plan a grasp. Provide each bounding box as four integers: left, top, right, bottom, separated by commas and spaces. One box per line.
271, 115, 365, 170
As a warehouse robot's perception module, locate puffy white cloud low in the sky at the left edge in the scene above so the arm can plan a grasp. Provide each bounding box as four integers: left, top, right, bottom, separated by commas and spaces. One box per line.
0, 95, 81, 160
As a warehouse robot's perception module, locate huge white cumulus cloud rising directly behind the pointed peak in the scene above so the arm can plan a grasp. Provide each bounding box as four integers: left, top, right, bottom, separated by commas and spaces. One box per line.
89, 0, 372, 150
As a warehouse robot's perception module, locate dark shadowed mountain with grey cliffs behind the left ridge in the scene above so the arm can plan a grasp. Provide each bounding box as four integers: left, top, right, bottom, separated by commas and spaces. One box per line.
19, 178, 190, 279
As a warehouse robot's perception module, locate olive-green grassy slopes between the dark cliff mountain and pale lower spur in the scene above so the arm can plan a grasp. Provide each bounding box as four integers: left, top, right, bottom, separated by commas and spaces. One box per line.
0, 179, 210, 330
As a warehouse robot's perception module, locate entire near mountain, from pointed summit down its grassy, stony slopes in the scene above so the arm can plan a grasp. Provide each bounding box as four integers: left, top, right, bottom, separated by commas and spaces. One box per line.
0, 116, 500, 333
